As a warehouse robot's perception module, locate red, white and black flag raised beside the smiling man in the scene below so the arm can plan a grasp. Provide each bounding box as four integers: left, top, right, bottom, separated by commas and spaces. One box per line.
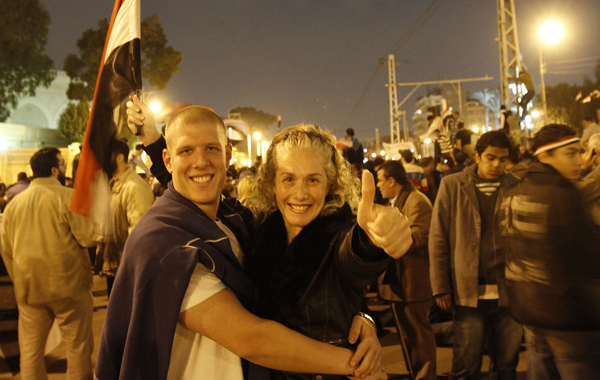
69, 0, 142, 225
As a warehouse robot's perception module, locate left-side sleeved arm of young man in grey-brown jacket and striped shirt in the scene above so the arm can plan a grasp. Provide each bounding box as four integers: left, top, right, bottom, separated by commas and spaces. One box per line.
429, 178, 452, 310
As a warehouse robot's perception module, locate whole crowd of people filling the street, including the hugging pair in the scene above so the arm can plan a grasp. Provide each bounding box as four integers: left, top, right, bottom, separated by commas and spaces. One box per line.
0, 101, 600, 380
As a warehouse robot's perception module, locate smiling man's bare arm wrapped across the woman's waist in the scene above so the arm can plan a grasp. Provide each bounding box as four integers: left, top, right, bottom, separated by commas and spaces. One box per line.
179, 289, 360, 375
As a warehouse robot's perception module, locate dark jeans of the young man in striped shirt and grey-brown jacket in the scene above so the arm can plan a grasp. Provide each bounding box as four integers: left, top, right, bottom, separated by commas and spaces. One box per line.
449, 300, 523, 380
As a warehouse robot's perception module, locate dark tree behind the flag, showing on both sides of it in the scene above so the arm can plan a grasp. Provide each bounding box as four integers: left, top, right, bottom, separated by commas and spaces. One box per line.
63, 15, 181, 101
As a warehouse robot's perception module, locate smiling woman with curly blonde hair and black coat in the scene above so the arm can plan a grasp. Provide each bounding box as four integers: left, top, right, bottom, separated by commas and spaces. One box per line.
241, 125, 396, 379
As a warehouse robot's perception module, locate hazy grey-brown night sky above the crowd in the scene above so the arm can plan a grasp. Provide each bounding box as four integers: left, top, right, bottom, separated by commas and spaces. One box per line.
41, 0, 600, 138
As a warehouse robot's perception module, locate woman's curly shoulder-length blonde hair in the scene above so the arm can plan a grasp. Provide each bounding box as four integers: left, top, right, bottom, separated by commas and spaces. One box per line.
248, 124, 360, 220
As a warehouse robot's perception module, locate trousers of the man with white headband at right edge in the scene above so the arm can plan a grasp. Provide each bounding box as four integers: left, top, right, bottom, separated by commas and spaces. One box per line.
525, 326, 600, 380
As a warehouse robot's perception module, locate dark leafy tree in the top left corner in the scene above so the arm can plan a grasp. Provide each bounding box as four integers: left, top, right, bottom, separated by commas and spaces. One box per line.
0, 0, 55, 121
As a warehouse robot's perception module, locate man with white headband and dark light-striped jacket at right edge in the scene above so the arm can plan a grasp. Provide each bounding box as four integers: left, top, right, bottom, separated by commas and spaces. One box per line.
503, 124, 600, 380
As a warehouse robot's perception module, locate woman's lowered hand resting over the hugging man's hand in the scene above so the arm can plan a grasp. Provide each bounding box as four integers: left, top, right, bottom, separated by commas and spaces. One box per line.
348, 315, 387, 379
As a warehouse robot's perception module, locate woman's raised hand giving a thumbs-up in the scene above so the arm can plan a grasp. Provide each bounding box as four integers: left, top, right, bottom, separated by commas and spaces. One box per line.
357, 170, 412, 259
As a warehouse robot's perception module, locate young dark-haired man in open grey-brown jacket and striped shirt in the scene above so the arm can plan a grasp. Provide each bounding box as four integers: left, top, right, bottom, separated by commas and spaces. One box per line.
429, 131, 523, 379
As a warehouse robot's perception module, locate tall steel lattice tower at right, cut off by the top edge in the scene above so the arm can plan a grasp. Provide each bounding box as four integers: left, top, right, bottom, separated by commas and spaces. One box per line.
497, 0, 523, 112
